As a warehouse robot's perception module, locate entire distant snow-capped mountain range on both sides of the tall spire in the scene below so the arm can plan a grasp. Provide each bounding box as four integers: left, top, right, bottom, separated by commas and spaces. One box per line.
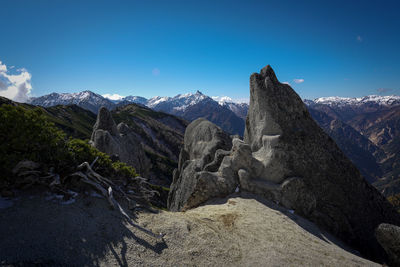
28, 91, 400, 195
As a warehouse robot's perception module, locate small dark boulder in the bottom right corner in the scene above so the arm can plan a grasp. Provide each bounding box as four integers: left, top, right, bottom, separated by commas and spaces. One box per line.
375, 223, 400, 266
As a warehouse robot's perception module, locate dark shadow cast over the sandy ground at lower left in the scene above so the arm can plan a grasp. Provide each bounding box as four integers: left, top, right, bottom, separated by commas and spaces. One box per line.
0, 191, 168, 266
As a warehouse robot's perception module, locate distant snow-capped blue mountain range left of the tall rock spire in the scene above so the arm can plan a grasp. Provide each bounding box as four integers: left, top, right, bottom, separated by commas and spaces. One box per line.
28, 91, 248, 135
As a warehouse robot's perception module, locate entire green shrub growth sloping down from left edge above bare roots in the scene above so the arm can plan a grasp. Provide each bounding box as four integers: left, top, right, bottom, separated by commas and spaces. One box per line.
0, 105, 137, 182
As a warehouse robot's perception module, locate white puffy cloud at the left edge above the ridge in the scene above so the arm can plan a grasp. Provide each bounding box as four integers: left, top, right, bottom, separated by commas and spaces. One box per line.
0, 61, 32, 102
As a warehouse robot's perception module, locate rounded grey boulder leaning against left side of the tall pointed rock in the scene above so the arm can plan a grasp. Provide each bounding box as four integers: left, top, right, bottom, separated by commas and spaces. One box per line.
168, 118, 237, 211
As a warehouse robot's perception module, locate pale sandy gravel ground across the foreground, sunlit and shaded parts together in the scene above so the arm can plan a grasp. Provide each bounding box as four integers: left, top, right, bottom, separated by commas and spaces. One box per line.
0, 193, 378, 266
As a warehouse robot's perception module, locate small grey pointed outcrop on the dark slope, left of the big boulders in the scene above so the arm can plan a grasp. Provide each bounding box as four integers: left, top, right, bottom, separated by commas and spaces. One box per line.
91, 107, 150, 176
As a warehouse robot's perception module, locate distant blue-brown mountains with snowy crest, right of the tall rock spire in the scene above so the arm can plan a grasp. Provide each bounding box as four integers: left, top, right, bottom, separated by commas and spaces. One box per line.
304, 95, 400, 196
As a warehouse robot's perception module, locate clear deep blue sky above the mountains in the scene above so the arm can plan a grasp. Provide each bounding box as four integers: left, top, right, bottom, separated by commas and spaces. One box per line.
0, 0, 400, 99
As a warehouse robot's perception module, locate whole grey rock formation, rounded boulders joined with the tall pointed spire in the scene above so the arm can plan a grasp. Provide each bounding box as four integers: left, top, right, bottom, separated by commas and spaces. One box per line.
168, 65, 400, 260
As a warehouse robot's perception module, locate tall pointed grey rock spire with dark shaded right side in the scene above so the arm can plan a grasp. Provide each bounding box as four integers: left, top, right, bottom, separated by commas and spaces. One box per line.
244, 66, 400, 258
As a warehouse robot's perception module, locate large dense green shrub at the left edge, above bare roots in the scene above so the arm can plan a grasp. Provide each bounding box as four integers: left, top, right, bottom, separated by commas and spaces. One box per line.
0, 105, 65, 177
